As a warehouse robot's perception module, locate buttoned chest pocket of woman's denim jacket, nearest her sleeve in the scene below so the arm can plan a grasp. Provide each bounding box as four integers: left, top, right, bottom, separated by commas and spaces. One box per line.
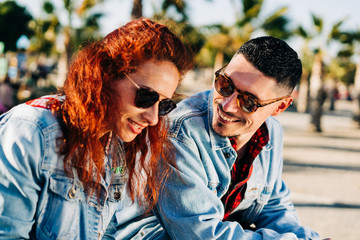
39, 174, 86, 239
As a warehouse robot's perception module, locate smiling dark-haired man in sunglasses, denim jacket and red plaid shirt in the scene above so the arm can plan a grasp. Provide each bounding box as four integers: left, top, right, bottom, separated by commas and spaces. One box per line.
152, 37, 319, 240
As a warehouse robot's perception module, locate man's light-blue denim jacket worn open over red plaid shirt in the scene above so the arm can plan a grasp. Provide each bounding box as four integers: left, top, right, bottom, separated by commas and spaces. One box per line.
158, 90, 319, 240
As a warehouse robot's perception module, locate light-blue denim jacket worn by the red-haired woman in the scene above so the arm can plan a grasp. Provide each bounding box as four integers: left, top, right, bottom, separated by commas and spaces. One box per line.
0, 98, 132, 240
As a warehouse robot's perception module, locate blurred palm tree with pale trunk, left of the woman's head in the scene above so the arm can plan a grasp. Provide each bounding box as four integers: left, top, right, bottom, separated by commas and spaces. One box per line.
31, 0, 103, 86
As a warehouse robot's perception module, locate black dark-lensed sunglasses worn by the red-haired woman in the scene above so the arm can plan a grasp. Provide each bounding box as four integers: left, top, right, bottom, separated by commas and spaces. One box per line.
124, 73, 176, 117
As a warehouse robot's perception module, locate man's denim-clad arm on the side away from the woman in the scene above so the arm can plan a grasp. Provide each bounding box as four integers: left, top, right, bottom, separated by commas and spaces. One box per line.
248, 119, 319, 239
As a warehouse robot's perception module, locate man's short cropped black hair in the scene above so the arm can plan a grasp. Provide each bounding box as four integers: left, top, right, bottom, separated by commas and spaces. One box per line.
236, 36, 302, 91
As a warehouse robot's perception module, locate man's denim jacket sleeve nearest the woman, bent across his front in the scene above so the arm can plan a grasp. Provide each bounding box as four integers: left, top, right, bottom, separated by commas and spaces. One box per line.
158, 133, 306, 240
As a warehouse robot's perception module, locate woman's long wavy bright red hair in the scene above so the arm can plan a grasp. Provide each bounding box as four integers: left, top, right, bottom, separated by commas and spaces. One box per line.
58, 18, 193, 209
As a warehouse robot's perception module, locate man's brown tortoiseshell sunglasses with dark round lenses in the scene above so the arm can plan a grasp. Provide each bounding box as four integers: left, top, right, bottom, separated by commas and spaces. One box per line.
215, 64, 290, 113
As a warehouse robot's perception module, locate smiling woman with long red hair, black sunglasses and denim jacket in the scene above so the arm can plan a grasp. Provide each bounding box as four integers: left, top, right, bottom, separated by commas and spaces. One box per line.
0, 18, 193, 240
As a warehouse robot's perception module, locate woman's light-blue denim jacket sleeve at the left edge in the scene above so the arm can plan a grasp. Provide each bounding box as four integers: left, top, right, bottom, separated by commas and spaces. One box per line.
0, 116, 44, 239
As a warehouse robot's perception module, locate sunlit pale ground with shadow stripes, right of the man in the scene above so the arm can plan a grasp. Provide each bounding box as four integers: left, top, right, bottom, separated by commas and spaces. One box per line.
277, 101, 360, 240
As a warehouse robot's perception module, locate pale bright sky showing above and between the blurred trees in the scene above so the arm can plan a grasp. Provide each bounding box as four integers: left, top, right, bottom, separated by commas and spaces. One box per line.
0, 0, 360, 53
